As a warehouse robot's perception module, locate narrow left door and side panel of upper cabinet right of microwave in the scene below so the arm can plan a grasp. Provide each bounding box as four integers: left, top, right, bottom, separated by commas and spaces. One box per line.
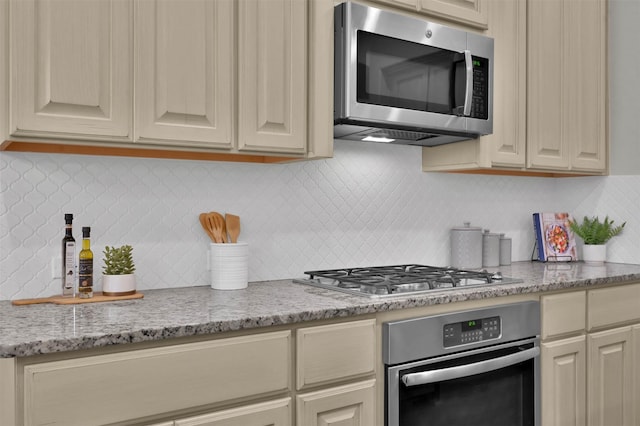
422, 0, 527, 171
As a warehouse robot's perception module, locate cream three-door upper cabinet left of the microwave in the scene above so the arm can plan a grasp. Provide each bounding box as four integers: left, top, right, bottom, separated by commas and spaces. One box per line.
5, 0, 333, 159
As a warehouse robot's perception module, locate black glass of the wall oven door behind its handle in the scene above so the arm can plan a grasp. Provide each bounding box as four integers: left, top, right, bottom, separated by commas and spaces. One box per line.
388, 343, 536, 426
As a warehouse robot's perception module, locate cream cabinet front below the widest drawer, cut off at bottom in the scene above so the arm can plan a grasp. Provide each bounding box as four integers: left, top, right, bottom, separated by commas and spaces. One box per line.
175, 398, 291, 426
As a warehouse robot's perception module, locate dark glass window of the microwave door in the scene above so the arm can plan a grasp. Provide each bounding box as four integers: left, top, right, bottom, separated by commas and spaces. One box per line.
357, 31, 466, 115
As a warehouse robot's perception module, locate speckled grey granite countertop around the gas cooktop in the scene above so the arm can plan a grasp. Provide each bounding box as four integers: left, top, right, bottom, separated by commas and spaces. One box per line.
0, 262, 640, 358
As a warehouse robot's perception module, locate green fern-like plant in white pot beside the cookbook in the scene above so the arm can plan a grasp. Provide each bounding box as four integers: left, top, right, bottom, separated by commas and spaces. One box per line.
569, 216, 627, 263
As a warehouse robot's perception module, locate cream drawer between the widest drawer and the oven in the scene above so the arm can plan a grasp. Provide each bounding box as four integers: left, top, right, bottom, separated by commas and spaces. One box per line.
297, 320, 376, 389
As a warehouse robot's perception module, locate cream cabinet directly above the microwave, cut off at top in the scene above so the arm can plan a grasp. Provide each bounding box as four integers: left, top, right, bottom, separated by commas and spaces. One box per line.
377, 0, 492, 29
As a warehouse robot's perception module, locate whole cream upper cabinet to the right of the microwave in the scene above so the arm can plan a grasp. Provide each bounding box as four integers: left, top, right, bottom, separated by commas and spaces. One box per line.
422, 0, 607, 175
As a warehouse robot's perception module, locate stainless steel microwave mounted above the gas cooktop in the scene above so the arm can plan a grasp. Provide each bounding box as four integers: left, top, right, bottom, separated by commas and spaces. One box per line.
334, 2, 493, 146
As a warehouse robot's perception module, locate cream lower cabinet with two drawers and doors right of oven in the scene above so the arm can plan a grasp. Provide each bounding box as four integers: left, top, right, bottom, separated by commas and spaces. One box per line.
541, 284, 640, 426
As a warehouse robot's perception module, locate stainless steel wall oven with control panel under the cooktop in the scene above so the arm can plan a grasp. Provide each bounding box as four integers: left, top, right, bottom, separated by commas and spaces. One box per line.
383, 302, 540, 426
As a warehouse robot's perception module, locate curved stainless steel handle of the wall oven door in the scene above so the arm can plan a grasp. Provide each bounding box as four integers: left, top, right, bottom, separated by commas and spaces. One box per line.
402, 346, 540, 386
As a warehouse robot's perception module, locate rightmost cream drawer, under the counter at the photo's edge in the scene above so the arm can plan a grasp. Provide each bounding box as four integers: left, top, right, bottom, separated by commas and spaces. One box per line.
587, 284, 640, 330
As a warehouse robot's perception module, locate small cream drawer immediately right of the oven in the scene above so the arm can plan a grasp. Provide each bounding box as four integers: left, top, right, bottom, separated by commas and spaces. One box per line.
541, 291, 587, 339
